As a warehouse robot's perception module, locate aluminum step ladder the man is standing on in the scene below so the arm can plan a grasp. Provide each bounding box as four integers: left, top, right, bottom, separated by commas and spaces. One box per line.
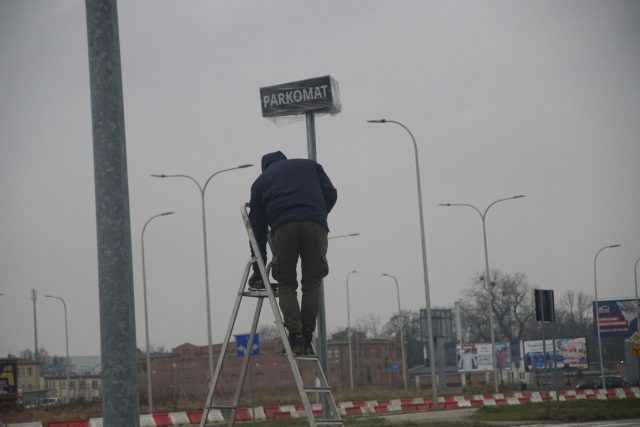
200, 203, 344, 427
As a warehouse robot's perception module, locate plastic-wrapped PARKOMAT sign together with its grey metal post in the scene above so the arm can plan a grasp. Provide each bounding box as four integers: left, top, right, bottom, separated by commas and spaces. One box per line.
260, 76, 342, 416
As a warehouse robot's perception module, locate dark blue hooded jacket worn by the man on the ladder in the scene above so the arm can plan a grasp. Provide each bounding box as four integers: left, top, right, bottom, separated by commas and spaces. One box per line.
249, 151, 338, 256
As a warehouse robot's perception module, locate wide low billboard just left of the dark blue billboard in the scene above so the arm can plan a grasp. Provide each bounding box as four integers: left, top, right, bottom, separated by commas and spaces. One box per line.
523, 337, 589, 371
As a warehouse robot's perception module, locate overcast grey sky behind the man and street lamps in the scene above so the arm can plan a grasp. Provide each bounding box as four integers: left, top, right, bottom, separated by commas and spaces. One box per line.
0, 0, 640, 355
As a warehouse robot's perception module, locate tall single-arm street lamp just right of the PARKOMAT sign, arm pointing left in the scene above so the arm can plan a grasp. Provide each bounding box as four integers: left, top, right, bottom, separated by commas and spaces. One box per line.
367, 119, 438, 409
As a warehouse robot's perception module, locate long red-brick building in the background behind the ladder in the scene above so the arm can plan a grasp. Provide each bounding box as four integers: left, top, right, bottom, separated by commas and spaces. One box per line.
138, 333, 403, 399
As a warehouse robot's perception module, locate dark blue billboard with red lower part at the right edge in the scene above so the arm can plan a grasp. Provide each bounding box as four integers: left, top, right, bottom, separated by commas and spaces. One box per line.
593, 298, 640, 338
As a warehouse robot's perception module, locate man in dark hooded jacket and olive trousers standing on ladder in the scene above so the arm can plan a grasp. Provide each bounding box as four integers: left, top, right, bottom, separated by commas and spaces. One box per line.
249, 151, 338, 355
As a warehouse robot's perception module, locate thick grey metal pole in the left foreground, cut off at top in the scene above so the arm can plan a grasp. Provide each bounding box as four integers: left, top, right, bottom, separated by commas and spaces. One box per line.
85, 0, 140, 427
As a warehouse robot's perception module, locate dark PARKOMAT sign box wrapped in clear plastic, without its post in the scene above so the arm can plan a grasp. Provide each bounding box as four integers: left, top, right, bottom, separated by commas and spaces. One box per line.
260, 76, 341, 118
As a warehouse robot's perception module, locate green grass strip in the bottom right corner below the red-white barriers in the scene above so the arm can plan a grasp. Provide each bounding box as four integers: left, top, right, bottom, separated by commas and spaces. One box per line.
473, 399, 640, 422
